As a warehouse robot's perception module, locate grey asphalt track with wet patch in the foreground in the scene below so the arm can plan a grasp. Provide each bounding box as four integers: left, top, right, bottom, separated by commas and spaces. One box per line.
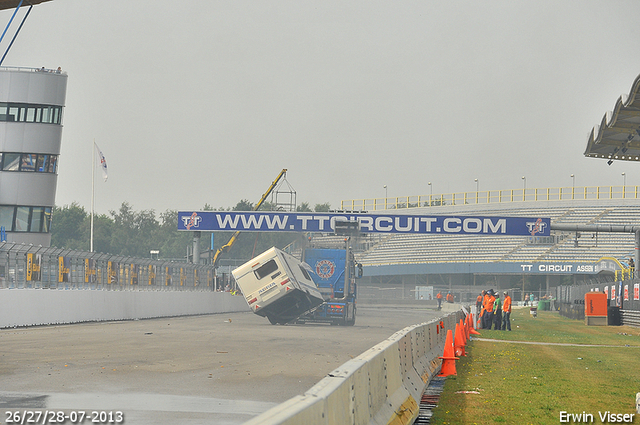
0, 306, 439, 425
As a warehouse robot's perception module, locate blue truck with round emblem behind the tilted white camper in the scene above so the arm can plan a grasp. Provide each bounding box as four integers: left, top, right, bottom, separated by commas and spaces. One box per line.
297, 248, 362, 326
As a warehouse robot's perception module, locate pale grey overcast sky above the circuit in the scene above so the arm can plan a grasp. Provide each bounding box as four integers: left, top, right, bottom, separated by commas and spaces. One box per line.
0, 0, 640, 213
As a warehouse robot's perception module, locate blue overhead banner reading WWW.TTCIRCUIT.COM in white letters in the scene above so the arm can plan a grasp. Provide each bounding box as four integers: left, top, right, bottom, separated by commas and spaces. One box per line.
178, 211, 551, 236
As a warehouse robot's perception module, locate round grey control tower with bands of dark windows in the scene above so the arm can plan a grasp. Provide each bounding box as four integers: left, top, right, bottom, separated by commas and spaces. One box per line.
0, 1, 67, 246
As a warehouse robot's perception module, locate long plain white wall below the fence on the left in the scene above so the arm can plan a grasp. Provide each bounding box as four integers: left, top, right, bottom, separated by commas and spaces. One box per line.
0, 289, 248, 328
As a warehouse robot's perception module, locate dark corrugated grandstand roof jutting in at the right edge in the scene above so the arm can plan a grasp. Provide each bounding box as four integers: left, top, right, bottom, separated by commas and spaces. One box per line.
584, 75, 640, 161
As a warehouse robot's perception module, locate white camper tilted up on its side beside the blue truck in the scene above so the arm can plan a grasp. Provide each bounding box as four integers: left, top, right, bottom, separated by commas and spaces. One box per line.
231, 247, 324, 325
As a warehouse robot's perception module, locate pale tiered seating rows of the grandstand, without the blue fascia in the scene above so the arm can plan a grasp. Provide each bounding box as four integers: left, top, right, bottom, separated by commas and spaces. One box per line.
359, 201, 640, 266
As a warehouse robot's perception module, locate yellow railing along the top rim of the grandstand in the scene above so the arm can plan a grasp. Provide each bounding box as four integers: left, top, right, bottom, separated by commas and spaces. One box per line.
340, 186, 640, 211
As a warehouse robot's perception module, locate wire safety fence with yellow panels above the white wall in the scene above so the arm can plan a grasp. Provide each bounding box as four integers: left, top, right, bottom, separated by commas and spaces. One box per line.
0, 242, 221, 291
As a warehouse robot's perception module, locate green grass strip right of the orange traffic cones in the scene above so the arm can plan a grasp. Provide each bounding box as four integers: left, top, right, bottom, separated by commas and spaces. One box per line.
431, 308, 640, 425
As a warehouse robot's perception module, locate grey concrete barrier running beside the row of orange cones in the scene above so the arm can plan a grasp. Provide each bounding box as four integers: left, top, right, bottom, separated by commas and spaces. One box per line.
245, 310, 464, 425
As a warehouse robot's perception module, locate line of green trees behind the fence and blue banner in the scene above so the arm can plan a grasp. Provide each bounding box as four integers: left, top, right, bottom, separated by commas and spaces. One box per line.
51, 199, 330, 260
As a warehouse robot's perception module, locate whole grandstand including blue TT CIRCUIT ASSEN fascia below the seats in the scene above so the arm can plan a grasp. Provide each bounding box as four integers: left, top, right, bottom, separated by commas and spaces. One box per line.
328, 187, 640, 300
